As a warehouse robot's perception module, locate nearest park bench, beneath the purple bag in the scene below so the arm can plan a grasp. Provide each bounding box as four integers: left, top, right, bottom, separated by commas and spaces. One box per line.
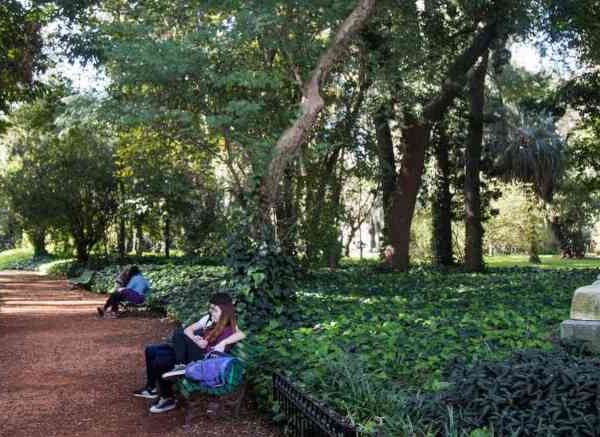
175, 354, 246, 426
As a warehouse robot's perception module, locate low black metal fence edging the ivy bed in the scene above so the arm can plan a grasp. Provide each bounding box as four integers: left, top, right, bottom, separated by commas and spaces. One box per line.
273, 373, 360, 437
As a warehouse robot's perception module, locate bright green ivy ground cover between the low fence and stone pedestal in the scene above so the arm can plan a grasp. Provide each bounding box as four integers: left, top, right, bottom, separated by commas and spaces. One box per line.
249, 268, 598, 429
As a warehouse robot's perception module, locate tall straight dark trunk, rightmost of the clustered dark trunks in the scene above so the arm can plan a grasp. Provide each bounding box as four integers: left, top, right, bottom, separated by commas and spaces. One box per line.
464, 52, 488, 272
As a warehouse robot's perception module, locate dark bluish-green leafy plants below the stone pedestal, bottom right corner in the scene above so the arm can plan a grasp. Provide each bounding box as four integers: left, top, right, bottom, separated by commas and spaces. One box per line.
419, 350, 600, 436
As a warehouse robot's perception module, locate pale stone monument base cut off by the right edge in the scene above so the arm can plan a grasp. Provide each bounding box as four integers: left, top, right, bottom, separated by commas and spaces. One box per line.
560, 275, 600, 352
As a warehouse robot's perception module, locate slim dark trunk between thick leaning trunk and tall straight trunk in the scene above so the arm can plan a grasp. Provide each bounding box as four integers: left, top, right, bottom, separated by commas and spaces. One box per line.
431, 122, 454, 266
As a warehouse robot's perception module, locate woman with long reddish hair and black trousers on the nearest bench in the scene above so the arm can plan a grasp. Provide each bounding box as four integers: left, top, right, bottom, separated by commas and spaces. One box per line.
133, 293, 246, 413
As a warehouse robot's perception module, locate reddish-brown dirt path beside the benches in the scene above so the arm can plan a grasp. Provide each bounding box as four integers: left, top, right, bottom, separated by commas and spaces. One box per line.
0, 271, 277, 437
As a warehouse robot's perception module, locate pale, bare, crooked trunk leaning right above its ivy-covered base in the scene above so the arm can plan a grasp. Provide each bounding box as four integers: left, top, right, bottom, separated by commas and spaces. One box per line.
261, 0, 376, 217
